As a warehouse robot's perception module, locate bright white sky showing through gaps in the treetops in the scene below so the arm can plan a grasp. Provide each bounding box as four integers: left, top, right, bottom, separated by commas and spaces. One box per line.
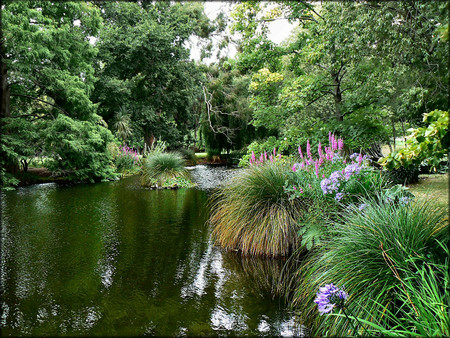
191, 1, 295, 63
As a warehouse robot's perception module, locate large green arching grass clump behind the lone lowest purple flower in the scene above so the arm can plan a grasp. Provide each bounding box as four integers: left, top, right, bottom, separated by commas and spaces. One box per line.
293, 196, 448, 336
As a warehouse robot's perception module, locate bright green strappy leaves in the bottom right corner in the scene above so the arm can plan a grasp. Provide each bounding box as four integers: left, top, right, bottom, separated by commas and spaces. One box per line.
356, 242, 450, 337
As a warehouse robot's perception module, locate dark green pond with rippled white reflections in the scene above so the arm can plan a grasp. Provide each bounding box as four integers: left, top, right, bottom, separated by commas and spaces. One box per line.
1, 166, 302, 336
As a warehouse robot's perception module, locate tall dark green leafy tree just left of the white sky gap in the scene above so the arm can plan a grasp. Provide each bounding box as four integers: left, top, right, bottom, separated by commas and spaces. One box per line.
94, 1, 212, 146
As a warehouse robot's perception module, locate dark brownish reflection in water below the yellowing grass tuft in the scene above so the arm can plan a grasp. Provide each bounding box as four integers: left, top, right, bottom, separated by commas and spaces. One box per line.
223, 252, 289, 298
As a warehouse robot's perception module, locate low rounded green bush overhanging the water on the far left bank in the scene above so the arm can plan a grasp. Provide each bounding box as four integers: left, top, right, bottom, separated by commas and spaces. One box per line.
42, 115, 114, 182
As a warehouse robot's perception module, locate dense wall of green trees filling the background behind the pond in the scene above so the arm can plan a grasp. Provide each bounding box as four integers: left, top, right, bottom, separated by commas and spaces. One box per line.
1, 1, 449, 189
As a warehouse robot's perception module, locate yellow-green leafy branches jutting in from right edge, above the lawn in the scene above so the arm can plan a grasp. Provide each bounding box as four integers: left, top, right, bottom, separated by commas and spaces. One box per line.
380, 110, 450, 170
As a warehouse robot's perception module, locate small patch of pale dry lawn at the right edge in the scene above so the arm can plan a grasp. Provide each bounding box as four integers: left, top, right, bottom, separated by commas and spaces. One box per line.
409, 173, 449, 208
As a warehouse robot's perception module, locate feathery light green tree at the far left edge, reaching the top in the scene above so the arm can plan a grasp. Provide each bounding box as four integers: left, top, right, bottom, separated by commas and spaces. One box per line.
0, 1, 109, 187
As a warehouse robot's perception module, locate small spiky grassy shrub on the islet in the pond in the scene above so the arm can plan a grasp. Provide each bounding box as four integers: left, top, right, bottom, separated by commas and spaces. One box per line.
141, 152, 194, 188
